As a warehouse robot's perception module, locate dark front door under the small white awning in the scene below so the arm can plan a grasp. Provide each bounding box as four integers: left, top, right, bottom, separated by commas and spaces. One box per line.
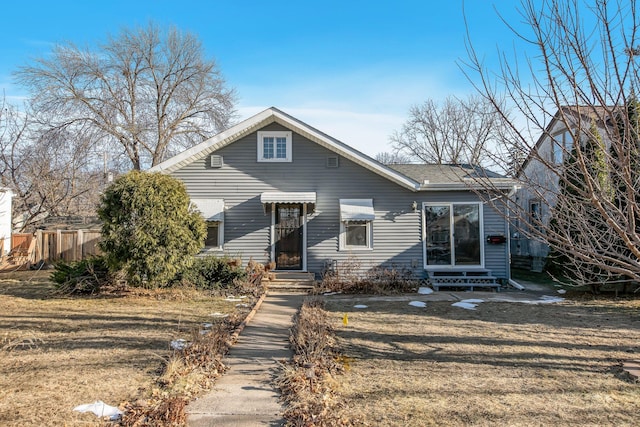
274, 204, 303, 270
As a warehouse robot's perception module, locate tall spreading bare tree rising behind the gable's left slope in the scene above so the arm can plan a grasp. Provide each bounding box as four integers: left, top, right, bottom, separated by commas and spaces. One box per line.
16, 24, 235, 169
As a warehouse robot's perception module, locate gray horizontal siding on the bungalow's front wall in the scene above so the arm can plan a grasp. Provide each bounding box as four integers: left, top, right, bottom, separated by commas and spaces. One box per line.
172, 123, 508, 277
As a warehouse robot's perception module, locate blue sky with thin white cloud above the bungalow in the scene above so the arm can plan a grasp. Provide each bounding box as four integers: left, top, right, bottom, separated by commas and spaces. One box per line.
0, 0, 521, 156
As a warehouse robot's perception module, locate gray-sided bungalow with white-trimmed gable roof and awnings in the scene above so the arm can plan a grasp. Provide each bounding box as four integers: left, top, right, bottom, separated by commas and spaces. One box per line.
151, 108, 514, 290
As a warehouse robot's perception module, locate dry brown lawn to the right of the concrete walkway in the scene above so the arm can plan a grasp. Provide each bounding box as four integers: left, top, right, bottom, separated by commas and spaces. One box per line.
326, 298, 640, 426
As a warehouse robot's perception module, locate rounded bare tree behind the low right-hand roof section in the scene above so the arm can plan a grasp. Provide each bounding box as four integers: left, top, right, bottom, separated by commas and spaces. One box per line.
390, 96, 509, 171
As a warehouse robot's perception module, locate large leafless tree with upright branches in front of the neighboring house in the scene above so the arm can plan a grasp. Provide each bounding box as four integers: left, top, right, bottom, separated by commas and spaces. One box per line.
467, 0, 640, 286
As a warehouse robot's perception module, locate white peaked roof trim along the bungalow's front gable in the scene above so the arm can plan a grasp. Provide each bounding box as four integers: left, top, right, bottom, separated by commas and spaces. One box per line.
149, 107, 420, 191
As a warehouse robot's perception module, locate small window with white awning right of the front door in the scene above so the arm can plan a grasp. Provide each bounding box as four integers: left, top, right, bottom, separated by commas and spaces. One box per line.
340, 199, 375, 250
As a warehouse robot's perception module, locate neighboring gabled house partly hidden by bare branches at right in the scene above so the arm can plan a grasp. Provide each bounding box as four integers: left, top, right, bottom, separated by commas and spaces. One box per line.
511, 106, 610, 271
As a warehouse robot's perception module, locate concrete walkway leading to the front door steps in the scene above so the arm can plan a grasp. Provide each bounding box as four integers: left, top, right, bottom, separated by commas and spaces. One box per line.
187, 292, 305, 427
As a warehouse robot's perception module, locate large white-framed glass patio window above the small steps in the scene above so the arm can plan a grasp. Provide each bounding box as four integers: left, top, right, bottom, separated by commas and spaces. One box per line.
424, 203, 483, 267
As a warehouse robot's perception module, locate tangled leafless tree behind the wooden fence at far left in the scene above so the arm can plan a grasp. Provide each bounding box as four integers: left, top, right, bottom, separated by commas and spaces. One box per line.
0, 101, 103, 230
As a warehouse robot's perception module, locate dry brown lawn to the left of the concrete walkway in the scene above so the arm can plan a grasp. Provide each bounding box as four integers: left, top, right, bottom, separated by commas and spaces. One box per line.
0, 271, 255, 426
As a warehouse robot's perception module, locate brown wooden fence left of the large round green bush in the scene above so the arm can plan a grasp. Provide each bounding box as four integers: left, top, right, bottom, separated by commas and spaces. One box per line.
11, 230, 101, 264
